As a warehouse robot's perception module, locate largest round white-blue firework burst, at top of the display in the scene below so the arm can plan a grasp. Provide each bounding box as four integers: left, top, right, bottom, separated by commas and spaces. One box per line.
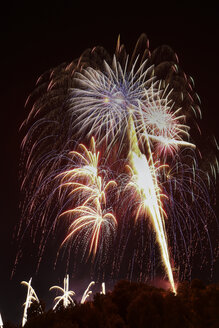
69, 56, 157, 154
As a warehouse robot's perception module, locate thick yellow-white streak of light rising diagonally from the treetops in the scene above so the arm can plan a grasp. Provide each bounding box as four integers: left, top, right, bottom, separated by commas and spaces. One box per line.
128, 117, 176, 294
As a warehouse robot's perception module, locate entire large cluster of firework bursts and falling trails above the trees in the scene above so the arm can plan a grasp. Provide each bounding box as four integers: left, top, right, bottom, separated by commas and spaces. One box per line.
19, 35, 218, 292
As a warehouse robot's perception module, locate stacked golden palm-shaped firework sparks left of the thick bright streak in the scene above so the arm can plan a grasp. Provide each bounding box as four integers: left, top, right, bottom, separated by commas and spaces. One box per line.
57, 138, 117, 257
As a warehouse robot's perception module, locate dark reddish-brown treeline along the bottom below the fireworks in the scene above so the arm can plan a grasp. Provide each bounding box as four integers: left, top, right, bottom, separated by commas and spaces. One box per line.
4, 280, 219, 328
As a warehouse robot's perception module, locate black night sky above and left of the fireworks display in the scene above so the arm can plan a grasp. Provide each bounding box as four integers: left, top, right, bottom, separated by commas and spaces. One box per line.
0, 1, 219, 321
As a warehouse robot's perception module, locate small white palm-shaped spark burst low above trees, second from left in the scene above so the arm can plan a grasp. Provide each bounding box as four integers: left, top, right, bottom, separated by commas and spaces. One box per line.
50, 275, 75, 310
